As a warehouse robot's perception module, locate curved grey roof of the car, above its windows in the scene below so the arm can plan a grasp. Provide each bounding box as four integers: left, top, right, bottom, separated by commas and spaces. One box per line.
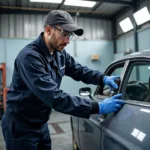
111, 49, 150, 64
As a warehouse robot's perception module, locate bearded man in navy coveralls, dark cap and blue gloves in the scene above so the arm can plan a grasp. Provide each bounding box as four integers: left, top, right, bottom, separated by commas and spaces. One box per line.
2, 10, 124, 150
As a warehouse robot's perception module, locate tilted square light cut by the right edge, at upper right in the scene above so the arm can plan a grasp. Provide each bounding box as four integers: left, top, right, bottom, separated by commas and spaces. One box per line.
133, 7, 150, 25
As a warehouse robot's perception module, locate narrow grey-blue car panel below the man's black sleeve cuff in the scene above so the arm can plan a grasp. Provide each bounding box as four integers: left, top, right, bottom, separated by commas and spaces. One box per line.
79, 96, 101, 150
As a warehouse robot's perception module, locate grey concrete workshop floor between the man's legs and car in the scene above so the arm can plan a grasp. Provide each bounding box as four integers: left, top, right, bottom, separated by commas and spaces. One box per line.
0, 111, 72, 150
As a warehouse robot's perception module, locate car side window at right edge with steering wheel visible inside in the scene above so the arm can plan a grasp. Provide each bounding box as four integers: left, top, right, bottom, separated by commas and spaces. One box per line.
124, 62, 150, 102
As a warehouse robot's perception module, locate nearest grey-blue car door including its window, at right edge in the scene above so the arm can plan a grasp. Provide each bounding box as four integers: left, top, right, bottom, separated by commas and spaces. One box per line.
101, 59, 150, 150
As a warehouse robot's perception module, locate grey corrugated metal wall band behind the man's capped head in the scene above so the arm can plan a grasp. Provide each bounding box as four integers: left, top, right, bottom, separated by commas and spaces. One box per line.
0, 14, 112, 40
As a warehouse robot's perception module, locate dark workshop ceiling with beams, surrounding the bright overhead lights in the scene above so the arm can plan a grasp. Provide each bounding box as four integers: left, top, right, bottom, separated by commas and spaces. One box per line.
0, 0, 145, 20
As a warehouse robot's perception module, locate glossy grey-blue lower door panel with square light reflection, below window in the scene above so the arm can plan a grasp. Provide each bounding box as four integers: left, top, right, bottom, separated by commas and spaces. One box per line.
101, 104, 150, 150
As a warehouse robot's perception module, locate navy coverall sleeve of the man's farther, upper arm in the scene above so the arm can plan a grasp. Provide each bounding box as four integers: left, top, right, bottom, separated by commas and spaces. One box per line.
66, 53, 104, 85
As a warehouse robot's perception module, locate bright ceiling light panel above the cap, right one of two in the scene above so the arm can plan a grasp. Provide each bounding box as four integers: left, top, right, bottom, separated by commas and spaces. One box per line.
64, 0, 96, 7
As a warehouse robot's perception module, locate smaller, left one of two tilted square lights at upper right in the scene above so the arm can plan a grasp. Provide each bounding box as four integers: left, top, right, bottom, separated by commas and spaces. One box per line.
119, 17, 133, 32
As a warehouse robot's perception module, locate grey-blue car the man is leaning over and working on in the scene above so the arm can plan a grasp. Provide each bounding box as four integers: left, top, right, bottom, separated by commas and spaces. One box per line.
71, 50, 150, 150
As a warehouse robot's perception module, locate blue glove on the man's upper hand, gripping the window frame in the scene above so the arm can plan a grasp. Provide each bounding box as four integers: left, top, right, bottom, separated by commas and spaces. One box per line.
103, 76, 120, 89
